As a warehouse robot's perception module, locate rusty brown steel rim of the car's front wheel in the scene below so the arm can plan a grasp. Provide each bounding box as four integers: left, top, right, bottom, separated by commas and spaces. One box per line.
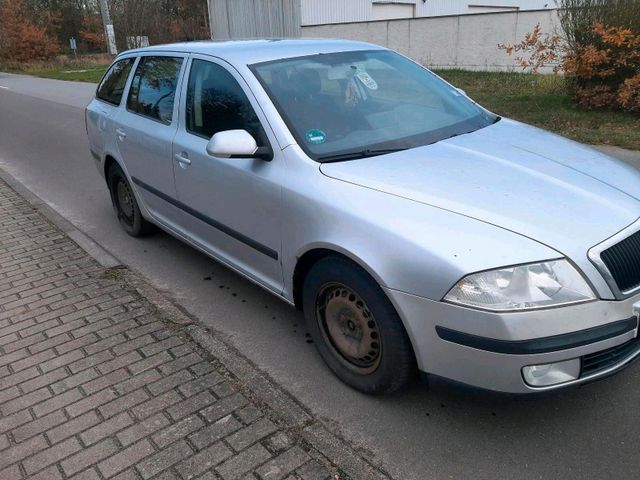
316, 283, 382, 374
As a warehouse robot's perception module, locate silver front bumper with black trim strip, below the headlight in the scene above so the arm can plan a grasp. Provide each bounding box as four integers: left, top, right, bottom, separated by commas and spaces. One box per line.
386, 289, 640, 393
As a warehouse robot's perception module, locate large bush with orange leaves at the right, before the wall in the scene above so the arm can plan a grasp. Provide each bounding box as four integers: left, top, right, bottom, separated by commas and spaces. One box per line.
498, 0, 640, 112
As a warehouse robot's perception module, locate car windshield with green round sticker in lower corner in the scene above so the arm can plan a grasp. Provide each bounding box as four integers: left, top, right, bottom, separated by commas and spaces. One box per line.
251, 50, 499, 162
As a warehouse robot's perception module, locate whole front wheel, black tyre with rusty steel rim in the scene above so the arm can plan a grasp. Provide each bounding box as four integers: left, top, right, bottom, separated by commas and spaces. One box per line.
302, 256, 417, 394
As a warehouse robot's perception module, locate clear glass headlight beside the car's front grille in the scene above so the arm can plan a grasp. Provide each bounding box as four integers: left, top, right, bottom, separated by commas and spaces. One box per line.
444, 260, 595, 311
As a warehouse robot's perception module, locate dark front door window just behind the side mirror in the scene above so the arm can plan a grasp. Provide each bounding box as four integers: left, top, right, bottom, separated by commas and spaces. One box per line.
186, 60, 264, 140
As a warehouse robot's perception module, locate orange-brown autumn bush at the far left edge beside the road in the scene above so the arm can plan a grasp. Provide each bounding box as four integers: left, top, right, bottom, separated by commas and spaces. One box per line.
0, 0, 60, 62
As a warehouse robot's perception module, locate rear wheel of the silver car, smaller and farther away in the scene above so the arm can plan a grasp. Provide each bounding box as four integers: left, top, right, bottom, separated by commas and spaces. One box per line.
107, 163, 154, 237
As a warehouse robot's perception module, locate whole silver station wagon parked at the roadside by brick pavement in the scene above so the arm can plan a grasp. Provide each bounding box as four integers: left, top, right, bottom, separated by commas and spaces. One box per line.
86, 40, 640, 393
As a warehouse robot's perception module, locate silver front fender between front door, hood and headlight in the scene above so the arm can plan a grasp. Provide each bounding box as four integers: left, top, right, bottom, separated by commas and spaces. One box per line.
283, 147, 562, 300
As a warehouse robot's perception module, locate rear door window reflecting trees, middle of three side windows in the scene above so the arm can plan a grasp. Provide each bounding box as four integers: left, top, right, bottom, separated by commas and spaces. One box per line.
127, 57, 182, 125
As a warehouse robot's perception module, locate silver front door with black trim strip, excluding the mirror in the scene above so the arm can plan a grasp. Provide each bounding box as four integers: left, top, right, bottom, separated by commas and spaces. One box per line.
173, 56, 284, 293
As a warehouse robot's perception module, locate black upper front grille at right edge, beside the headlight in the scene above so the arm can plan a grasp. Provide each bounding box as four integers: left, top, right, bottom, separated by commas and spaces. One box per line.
600, 231, 640, 292
